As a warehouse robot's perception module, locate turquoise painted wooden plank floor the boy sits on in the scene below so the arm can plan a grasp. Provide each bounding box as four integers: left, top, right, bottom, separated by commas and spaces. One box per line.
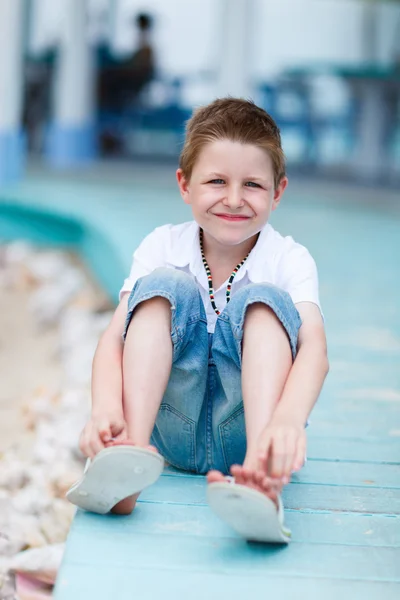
0, 165, 400, 600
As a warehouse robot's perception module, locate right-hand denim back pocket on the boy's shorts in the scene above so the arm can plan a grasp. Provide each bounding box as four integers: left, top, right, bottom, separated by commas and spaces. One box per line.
219, 404, 246, 473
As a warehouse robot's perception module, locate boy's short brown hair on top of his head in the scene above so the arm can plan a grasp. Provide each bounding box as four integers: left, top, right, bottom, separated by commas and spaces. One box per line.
179, 98, 286, 188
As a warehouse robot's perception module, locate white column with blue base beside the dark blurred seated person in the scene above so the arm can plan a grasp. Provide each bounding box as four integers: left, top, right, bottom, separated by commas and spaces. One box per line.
47, 0, 96, 167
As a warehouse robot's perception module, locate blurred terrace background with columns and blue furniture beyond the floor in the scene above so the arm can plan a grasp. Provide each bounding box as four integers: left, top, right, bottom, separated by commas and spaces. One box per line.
0, 0, 400, 185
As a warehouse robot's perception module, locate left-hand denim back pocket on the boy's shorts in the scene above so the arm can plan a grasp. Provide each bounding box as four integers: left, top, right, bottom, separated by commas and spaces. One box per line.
151, 403, 196, 471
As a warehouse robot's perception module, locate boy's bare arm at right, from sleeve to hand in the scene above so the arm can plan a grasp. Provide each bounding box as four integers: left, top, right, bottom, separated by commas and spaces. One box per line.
259, 302, 329, 483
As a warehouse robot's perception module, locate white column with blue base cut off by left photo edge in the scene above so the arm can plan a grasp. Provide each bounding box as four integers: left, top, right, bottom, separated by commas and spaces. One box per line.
0, 0, 25, 185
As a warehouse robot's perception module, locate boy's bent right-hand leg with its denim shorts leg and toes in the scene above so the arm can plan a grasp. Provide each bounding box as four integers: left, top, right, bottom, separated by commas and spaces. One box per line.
210, 284, 301, 496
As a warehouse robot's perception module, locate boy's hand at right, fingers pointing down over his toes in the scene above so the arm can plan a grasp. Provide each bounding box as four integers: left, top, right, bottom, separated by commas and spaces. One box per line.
258, 417, 307, 484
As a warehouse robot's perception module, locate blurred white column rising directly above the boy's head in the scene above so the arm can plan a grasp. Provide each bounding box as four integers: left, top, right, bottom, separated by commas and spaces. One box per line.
217, 0, 254, 98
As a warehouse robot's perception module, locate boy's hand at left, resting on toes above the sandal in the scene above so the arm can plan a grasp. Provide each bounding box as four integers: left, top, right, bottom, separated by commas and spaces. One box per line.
79, 411, 128, 458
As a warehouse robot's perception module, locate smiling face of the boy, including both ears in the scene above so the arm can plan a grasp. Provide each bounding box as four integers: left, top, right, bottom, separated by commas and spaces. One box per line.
177, 140, 287, 246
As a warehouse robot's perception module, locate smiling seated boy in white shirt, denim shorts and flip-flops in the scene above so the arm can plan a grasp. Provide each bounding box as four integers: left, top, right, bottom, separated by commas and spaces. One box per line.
68, 98, 328, 541
